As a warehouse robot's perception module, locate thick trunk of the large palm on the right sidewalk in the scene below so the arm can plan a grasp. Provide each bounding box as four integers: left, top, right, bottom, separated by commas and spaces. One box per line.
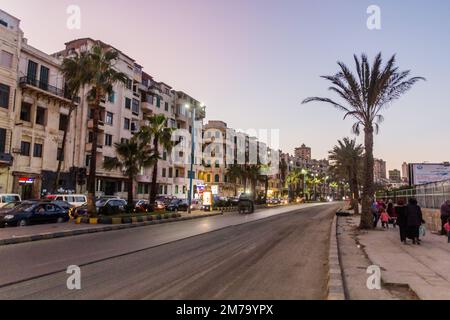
360, 126, 374, 229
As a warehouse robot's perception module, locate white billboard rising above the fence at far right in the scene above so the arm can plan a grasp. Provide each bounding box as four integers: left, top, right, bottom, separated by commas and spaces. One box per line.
409, 163, 450, 185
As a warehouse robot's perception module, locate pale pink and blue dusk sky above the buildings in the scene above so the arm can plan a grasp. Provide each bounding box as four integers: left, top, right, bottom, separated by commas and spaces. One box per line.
0, 0, 450, 169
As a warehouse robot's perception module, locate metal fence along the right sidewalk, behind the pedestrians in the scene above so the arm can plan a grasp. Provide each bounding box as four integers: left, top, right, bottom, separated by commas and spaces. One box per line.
377, 180, 450, 209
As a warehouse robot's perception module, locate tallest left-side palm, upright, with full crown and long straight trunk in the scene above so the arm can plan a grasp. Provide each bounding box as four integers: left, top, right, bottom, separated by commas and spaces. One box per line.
84, 43, 128, 215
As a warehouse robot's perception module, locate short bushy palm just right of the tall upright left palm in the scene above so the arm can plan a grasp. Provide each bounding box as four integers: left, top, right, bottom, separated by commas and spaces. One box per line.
103, 139, 156, 206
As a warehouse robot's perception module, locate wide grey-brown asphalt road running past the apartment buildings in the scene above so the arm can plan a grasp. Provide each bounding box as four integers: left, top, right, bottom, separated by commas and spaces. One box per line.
0, 205, 338, 300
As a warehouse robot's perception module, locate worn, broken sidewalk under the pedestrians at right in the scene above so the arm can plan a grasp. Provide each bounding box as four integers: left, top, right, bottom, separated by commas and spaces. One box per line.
338, 217, 450, 300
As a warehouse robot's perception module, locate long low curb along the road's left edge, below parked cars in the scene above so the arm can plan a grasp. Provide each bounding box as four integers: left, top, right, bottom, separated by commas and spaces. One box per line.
0, 213, 222, 246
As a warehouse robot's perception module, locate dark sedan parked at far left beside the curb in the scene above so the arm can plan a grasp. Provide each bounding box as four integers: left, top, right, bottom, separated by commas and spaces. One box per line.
0, 202, 69, 227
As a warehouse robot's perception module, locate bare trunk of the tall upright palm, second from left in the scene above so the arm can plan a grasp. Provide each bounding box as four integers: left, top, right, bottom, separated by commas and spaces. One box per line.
87, 100, 100, 216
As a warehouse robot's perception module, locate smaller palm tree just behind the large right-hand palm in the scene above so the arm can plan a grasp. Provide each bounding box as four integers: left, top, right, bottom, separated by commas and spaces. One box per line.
329, 138, 364, 214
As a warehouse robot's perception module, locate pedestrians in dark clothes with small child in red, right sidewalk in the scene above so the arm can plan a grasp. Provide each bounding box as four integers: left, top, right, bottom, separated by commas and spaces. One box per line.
372, 198, 426, 245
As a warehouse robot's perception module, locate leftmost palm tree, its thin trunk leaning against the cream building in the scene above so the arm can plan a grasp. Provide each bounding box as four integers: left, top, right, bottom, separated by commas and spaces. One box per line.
53, 52, 90, 192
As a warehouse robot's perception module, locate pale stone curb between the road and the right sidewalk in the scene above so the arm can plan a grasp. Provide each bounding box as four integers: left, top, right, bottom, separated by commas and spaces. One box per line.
327, 215, 346, 300
